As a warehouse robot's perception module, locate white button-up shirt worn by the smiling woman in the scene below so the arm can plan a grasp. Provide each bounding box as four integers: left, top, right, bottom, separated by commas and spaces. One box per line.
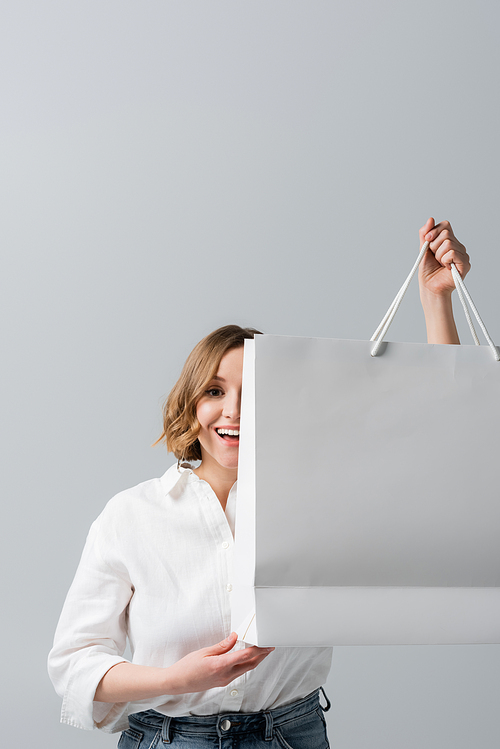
49, 466, 331, 733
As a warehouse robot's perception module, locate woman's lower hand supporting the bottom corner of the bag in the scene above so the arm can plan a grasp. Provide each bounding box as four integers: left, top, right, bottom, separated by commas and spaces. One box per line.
167, 632, 274, 694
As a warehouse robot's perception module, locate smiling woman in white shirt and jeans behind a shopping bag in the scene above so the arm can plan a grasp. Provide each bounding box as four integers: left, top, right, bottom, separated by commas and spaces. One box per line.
49, 219, 470, 749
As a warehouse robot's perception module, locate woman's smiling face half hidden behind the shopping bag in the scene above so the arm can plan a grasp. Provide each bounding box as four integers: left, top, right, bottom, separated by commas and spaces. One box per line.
196, 346, 243, 472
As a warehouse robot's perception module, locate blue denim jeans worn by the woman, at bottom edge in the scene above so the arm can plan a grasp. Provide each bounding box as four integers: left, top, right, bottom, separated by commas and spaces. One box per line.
118, 690, 330, 749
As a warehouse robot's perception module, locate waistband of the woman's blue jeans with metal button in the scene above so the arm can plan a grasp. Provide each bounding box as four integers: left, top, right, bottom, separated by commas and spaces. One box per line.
129, 689, 330, 744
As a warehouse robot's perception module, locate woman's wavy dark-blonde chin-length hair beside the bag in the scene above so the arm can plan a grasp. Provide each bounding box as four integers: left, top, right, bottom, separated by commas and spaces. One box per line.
155, 325, 260, 460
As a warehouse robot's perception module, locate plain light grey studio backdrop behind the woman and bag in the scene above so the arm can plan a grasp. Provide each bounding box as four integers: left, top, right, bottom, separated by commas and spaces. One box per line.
0, 0, 500, 749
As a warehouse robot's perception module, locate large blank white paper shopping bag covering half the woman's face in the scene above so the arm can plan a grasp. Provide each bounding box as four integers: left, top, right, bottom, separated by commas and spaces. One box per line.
232, 250, 500, 646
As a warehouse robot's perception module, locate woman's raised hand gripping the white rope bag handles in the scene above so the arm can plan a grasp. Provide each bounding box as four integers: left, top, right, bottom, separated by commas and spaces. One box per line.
419, 218, 470, 296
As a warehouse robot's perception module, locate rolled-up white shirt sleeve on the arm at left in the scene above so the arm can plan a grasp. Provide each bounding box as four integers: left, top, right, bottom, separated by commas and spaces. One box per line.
48, 513, 133, 729
